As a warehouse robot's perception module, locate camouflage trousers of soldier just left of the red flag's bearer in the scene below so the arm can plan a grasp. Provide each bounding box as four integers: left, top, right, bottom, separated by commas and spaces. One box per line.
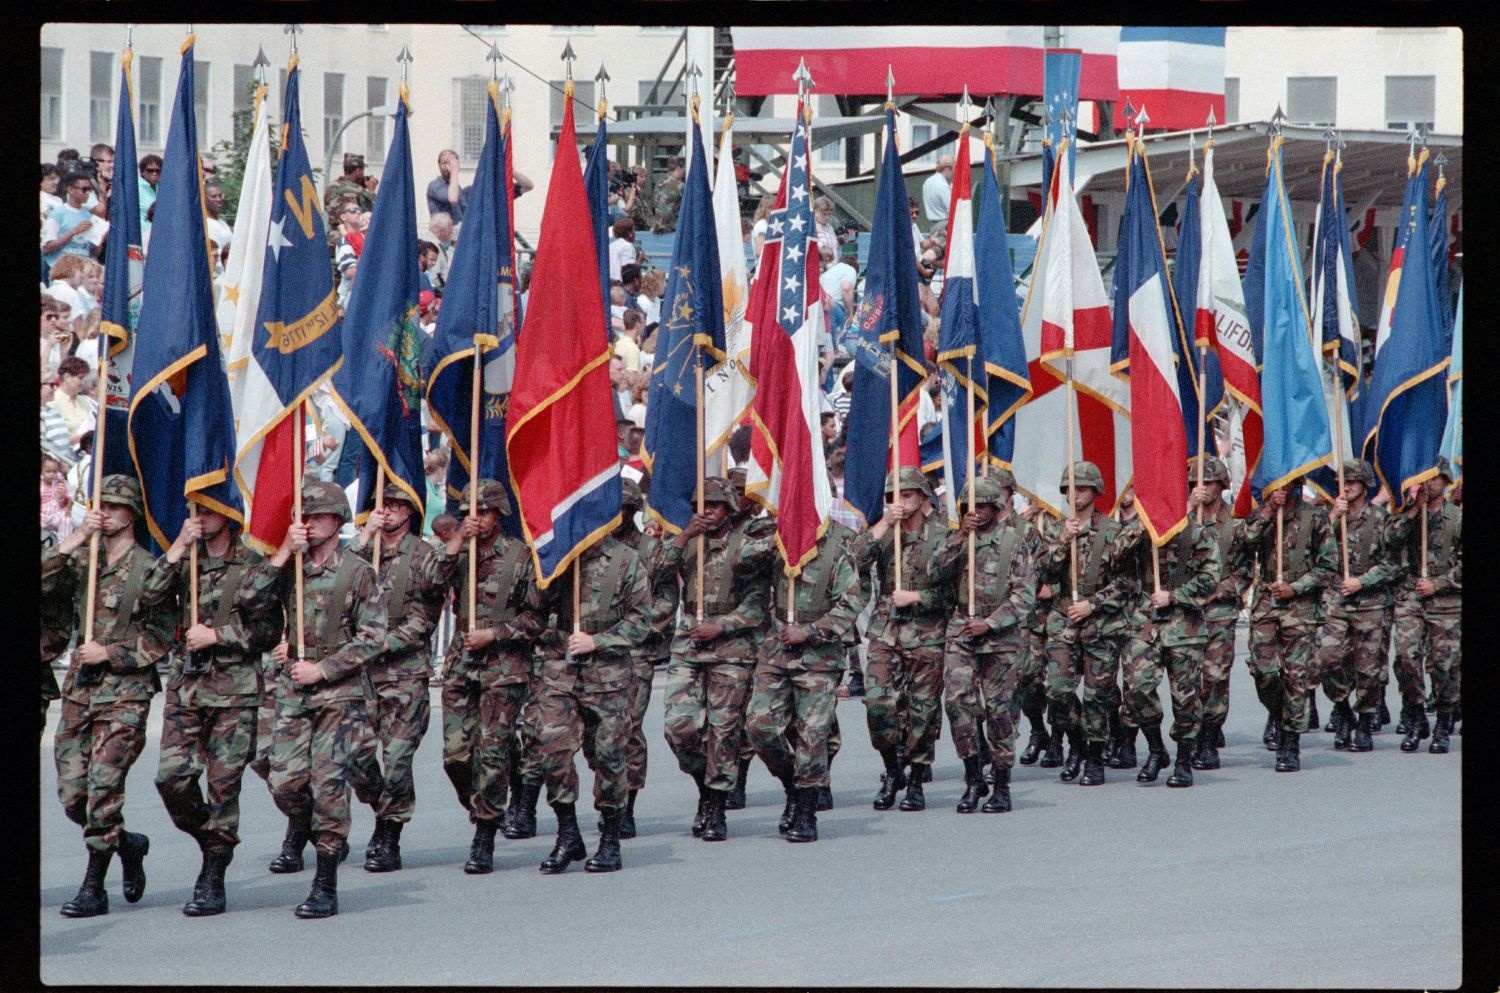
443, 672, 528, 822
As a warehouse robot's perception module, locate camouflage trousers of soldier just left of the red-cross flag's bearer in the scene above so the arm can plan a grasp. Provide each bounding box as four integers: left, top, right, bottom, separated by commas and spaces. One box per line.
942, 639, 1026, 768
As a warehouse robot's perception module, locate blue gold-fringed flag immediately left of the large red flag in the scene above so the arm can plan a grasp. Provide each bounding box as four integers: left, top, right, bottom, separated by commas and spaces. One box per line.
423, 83, 521, 537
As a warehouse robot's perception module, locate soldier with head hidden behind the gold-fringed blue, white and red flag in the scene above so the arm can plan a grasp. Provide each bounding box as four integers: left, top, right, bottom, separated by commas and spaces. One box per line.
1115, 501, 1223, 786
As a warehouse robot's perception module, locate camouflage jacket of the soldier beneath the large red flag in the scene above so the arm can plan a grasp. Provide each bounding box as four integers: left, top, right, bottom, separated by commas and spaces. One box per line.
527, 537, 651, 693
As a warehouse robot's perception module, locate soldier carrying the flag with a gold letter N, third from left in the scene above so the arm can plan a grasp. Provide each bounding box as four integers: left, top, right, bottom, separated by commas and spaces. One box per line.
270, 480, 386, 918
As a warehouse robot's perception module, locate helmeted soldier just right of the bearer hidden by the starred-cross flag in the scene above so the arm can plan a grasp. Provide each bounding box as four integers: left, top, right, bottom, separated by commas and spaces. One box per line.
851, 467, 953, 810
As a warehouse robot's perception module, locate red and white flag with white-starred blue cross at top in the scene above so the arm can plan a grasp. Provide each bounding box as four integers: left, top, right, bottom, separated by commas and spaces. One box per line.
746, 101, 834, 576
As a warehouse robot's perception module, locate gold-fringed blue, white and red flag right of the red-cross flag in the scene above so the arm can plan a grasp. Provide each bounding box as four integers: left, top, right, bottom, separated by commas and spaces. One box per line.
1115, 141, 1188, 545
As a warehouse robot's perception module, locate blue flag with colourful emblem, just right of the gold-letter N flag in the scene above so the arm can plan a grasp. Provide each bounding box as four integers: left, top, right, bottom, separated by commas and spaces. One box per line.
333, 84, 428, 519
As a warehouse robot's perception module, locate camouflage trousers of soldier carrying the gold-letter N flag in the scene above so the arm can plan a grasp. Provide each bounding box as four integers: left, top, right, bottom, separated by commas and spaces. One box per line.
269, 701, 381, 855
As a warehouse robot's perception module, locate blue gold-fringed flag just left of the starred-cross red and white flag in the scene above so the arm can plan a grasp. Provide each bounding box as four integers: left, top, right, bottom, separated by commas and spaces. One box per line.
642, 110, 726, 533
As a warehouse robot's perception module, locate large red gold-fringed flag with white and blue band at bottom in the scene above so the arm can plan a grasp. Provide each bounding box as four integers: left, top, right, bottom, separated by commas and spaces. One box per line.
506, 80, 620, 587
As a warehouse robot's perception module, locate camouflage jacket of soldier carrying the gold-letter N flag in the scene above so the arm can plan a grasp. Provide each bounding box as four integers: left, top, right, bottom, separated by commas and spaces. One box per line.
278, 546, 386, 713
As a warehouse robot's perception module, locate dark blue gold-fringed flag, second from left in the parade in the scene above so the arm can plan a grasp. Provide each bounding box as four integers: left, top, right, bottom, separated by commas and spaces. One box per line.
129, 46, 245, 548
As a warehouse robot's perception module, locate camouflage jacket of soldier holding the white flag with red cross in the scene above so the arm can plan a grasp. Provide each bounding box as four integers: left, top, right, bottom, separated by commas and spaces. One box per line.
1037, 513, 1137, 642
